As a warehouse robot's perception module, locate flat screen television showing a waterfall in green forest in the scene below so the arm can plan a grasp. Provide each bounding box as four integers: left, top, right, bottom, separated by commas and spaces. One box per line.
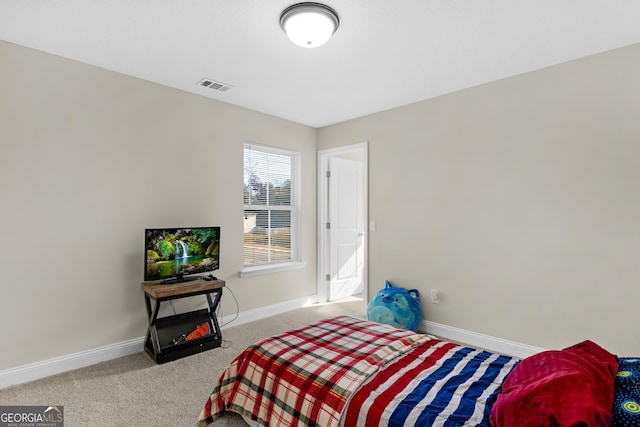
144, 227, 220, 283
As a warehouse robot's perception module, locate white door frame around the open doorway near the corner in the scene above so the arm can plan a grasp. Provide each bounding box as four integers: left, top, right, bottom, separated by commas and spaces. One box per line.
317, 142, 369, 309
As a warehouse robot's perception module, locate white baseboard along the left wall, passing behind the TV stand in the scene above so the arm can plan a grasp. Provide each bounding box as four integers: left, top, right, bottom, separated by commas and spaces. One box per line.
0, 297, 314, 388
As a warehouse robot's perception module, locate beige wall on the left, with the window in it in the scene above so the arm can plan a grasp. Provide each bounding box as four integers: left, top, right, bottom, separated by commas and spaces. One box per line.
0, 42, 317, 370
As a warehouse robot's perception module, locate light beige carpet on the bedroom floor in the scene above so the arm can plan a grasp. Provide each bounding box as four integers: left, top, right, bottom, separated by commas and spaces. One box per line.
0, 298, 364, 427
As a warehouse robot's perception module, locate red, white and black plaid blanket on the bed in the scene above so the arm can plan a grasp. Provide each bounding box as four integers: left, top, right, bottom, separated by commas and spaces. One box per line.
198, 316, 431, 427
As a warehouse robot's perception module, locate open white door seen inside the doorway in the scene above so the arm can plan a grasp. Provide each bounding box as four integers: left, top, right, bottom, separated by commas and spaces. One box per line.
328, 157, 364, 301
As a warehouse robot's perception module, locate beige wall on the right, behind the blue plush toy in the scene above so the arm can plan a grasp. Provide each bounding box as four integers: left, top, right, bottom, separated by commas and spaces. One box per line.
318, 45, 640, 355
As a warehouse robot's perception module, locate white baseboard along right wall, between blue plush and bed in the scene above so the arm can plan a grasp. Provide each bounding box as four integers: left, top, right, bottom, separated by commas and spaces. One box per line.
420, 320, 546, 359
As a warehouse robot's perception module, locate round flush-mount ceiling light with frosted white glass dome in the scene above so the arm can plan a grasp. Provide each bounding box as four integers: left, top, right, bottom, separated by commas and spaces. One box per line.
280, 2, 340, 48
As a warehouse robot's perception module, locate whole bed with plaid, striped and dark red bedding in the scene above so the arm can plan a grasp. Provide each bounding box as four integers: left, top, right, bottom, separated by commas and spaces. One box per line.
198, 316, 640, 427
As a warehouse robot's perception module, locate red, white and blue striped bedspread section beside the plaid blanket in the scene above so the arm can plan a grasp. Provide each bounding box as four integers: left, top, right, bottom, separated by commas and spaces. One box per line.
342, 340, 518, 427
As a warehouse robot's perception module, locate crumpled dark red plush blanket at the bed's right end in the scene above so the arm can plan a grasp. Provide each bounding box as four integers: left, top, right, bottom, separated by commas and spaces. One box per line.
491, 341, 618, 427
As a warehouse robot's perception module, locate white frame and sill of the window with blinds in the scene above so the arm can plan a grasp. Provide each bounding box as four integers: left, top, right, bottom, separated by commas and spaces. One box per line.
240, 142, 306, 277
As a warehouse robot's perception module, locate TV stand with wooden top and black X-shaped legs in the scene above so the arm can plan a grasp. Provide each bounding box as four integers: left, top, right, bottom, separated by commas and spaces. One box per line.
142, 279, 225, 363
